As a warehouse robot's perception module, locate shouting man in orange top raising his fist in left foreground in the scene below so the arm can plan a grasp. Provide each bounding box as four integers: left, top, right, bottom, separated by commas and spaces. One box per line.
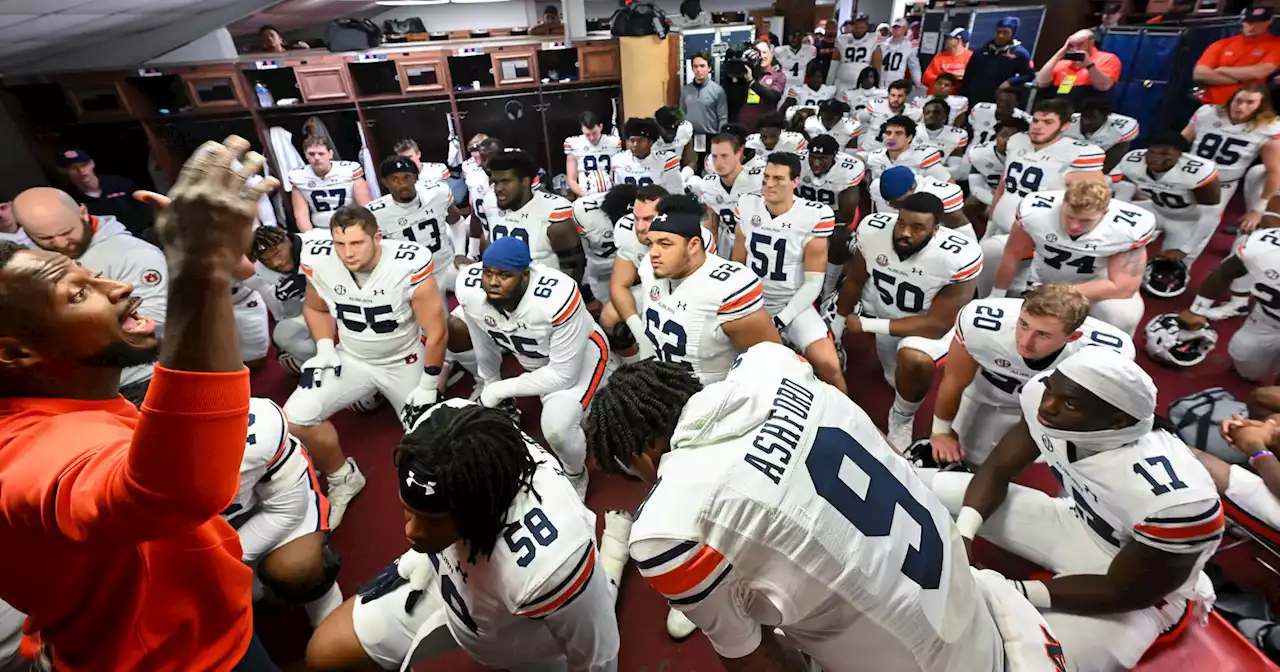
0, 137, 276, 672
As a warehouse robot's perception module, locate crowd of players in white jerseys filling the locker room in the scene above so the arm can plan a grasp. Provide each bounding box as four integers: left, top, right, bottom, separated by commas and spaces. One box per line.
13, 18, 1280, 672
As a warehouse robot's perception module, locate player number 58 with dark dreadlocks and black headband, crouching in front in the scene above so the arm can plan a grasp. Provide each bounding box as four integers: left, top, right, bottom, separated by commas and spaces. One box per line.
307, 399, 616, 672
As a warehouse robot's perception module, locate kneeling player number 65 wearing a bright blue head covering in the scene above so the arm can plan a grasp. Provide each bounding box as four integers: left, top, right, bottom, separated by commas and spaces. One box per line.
454, 236, 609, 498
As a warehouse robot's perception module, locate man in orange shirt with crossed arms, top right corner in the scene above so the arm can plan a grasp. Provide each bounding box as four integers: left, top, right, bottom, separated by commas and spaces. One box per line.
1192, 5, 1280, 105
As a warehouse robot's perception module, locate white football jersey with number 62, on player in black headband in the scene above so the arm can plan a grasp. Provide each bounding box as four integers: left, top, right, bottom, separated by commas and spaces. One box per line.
636, 256, 764, 385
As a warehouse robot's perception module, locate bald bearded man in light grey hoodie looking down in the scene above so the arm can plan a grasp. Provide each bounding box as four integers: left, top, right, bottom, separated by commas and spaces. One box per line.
13, 187, 169, 403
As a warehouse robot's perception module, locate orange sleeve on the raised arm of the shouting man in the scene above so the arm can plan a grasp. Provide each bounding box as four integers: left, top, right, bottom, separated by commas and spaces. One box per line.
50, 365, 250, 544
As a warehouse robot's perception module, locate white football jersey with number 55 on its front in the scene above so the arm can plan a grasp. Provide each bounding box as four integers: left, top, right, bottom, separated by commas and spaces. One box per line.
298, 238, 435, 365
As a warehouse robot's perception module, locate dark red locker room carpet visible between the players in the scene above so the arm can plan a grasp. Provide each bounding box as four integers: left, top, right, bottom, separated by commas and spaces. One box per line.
253, 227, 1280, 672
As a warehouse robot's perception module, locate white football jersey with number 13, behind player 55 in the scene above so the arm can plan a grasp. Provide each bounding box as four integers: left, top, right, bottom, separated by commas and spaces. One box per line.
369, 182, 454, 273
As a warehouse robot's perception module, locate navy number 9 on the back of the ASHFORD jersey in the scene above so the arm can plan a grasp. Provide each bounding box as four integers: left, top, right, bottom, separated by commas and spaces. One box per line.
805, 428, 945, 590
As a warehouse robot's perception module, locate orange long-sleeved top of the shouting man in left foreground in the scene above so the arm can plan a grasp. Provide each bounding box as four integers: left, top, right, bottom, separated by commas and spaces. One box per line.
0, 366, 253, 672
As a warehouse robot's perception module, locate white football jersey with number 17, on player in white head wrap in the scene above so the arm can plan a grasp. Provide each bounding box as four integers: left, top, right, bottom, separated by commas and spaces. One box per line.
1021, 372, 1224, 599
